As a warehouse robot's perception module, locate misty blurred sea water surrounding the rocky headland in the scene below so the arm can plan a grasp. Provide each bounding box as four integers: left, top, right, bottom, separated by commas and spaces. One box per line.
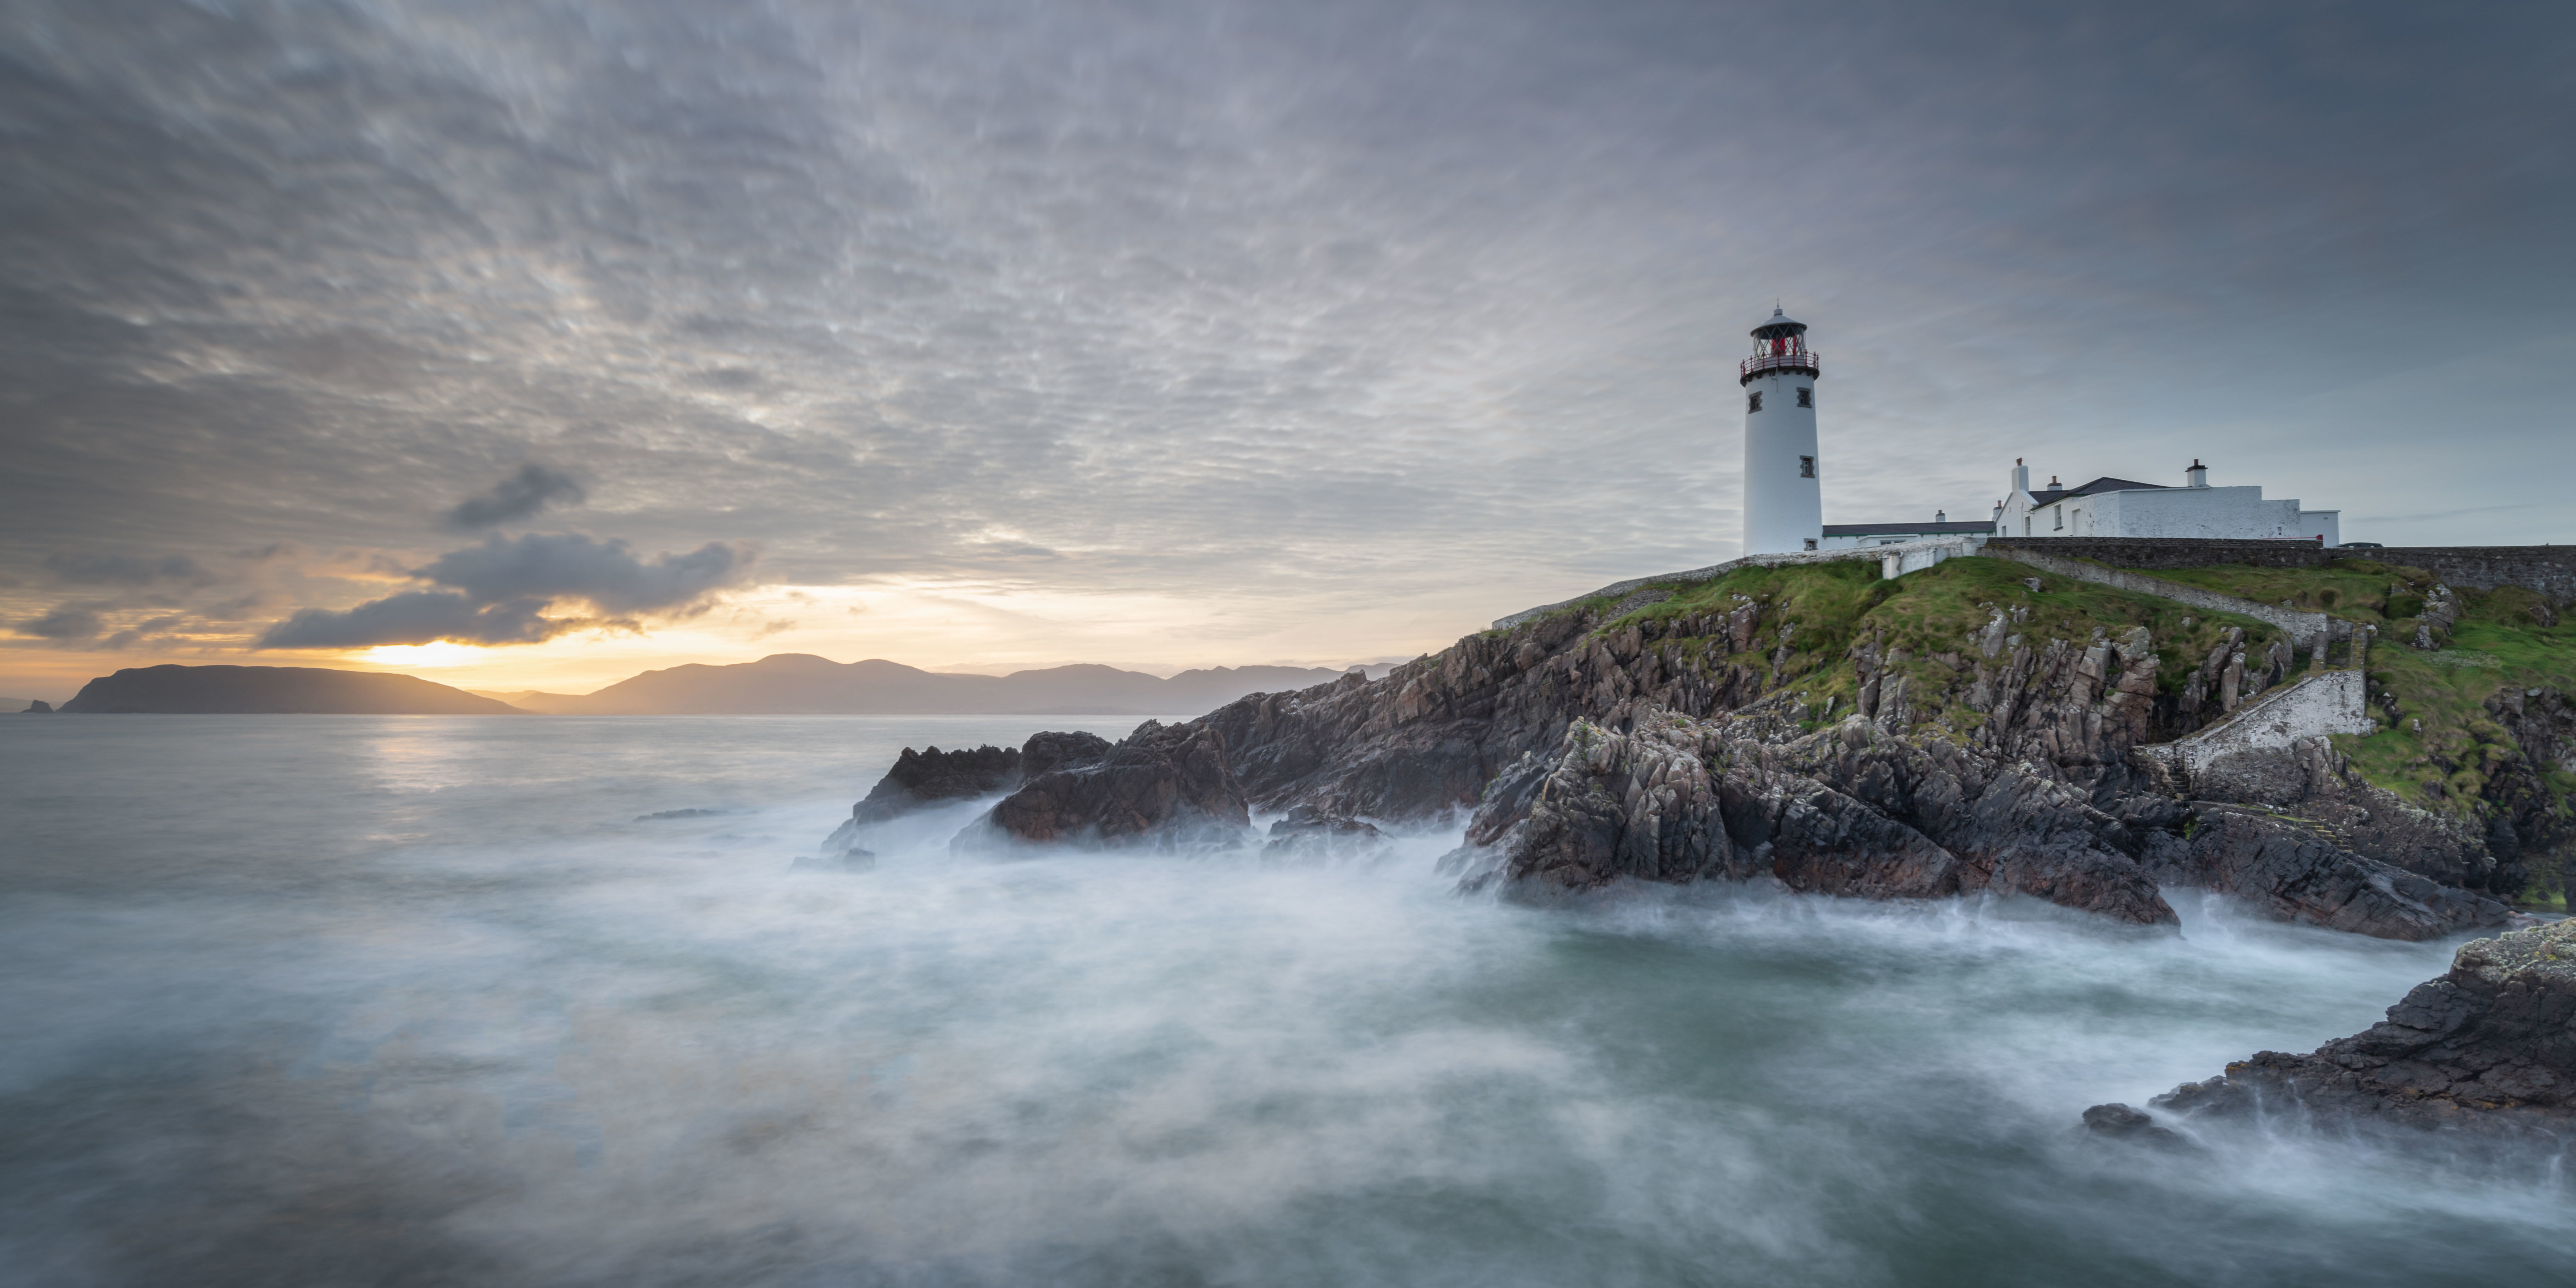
0, 716, 2568, 1285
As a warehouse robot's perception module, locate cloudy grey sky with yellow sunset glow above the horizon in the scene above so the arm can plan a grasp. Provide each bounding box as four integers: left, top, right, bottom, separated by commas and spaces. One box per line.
0, 0, 2576, 698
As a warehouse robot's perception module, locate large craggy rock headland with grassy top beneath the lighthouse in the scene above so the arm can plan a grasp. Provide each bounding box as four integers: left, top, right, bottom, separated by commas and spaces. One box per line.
850, 559, 2576, 940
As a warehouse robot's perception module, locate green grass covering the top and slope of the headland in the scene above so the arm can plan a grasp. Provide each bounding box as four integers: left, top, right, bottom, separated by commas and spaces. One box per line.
1504, 559, 2576, 899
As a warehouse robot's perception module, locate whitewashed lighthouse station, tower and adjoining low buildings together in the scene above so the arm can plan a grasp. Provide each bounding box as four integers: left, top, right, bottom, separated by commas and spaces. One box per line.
1739, 309, 2344, 554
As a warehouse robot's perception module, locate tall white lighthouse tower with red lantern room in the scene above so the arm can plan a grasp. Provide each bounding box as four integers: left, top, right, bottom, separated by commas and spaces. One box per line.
1739, 309, 1824, 554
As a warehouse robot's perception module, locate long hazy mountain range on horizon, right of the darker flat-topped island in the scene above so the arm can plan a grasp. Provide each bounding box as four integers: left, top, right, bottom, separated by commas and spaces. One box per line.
474, 652, 1342, 716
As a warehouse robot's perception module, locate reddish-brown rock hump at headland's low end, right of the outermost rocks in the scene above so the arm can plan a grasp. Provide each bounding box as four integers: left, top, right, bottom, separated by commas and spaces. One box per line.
961, 721, 1252, 848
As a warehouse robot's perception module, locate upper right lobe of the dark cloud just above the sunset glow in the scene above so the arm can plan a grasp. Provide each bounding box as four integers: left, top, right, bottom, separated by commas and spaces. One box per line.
415, 533, 752, 613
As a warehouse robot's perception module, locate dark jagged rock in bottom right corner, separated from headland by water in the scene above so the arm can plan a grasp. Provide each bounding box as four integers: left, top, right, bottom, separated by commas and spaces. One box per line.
2148, 920, 2576, 1149
